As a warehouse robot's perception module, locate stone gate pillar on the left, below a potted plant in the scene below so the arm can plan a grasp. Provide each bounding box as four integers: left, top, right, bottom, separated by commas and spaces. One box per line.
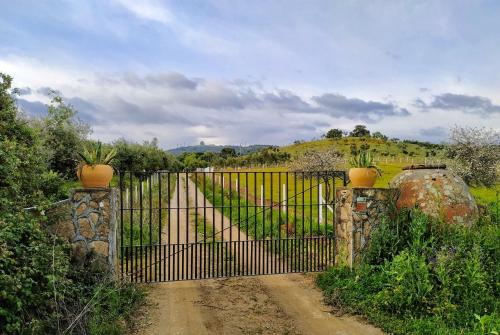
46, 188, 118, 276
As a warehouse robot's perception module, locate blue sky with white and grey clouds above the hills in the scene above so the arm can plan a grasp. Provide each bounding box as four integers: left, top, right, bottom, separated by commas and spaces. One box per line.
0, 0, 500, 148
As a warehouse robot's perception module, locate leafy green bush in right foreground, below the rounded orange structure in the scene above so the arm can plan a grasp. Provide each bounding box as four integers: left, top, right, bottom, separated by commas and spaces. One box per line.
318, 210, 500, 334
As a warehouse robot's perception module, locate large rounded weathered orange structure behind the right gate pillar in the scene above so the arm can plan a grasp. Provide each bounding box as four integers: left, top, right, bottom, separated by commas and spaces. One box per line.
390, 166, 478, 225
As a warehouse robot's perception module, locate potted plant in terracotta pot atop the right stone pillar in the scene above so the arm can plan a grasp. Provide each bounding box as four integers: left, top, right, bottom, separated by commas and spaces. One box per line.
349, 149, 382, 187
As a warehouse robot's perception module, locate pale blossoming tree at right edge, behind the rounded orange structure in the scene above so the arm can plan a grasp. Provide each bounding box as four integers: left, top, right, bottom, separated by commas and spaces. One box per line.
447, 126, 500, 186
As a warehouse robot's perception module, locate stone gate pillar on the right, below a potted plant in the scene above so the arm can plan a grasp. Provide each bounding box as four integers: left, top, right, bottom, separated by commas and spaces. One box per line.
335, 188, 397, 267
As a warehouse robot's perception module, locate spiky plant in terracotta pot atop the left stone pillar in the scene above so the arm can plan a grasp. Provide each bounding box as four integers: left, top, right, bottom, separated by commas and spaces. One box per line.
76, 141, 116, 188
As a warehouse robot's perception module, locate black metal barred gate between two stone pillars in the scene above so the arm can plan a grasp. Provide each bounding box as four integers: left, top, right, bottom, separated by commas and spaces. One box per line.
119, 171, 347, 282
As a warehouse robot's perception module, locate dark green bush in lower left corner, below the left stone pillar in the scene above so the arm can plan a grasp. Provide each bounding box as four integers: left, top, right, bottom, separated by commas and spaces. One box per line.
0, 214, 144, 334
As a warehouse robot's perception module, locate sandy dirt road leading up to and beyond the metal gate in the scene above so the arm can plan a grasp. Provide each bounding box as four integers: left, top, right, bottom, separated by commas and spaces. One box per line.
136, 179, 383, 335
